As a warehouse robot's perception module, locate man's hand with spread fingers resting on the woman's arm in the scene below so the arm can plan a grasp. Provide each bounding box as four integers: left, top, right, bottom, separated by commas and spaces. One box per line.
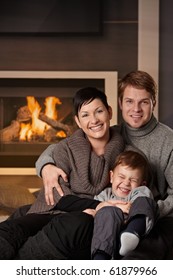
42, 164, 68, 205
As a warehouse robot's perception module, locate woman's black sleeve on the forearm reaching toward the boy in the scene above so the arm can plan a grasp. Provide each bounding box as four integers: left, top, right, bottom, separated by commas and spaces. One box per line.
56, 195, 100, 212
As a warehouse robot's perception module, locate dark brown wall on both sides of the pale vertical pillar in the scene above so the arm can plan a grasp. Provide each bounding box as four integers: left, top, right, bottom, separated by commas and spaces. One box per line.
0, 0, 173, 128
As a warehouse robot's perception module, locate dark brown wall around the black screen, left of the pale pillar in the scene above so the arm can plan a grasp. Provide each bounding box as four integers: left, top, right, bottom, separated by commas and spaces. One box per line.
0, 0, 138, 76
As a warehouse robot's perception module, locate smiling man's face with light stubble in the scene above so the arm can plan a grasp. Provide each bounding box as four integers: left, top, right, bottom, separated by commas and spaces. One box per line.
119, 86, 155, 128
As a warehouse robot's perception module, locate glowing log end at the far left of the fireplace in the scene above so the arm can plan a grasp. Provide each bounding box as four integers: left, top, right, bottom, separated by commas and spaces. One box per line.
0, 121, 20, 142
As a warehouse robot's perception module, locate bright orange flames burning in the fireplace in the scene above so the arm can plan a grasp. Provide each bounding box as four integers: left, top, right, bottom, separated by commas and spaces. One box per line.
19, 96, 64, 141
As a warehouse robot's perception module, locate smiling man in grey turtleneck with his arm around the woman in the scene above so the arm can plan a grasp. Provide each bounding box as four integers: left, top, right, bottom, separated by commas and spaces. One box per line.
36, 71, 173, 259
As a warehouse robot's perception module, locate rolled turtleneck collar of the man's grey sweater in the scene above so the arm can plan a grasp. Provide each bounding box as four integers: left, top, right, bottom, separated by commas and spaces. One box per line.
121, 115, 158, 137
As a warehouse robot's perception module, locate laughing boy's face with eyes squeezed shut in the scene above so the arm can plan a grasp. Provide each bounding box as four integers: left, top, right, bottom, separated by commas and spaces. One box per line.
110, 164, 145, 197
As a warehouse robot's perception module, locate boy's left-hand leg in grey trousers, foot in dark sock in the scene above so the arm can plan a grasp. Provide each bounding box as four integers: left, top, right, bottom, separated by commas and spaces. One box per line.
91, 206, 124, 259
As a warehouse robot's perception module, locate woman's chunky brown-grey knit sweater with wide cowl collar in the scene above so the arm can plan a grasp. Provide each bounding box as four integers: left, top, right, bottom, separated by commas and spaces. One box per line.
28, 127, 125, 213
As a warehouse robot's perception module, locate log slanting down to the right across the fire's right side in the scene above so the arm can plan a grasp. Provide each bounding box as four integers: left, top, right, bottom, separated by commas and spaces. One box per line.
39, 113, 73, 136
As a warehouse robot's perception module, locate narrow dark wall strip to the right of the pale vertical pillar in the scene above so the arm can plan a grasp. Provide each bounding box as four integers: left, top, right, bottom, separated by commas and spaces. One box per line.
159, 0, 173, 128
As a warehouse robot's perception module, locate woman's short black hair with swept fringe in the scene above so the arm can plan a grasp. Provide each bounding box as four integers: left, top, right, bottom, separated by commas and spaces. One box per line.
73, 87, 109, 116
